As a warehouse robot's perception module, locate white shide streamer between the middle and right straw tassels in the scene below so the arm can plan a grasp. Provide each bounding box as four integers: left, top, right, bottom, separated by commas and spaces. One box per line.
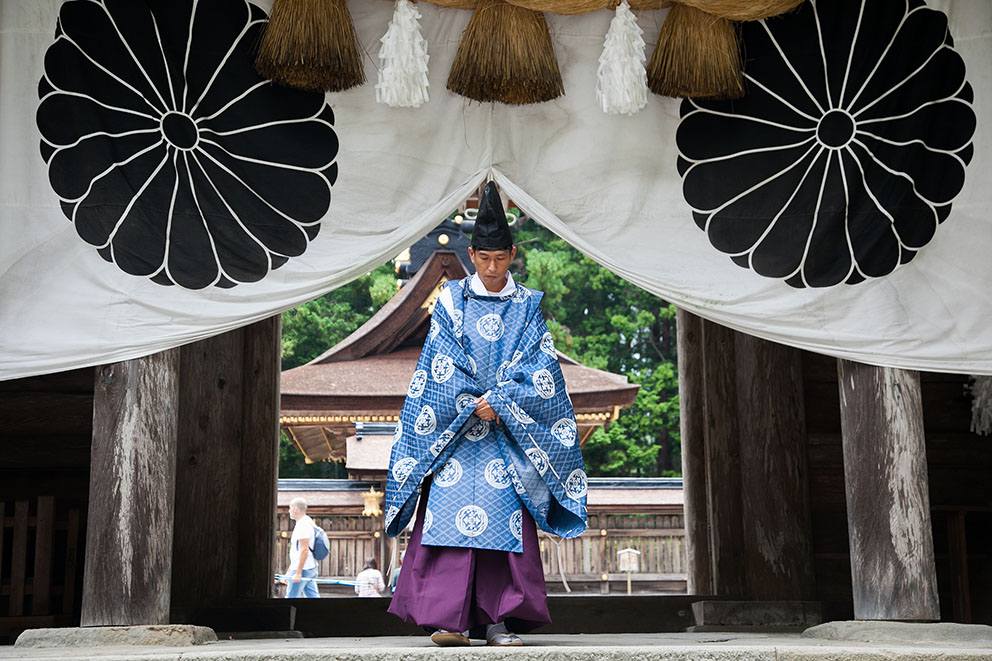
596, 0, 648, 115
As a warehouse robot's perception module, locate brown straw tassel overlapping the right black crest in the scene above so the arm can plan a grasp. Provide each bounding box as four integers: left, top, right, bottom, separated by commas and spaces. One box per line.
648, 4, 744, 99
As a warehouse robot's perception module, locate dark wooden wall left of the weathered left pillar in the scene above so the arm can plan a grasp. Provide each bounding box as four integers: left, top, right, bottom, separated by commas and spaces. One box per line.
0, 368, 94, 644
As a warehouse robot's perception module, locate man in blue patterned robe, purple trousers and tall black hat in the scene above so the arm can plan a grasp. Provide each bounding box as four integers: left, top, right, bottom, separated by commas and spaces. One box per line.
386, 182, 586, 645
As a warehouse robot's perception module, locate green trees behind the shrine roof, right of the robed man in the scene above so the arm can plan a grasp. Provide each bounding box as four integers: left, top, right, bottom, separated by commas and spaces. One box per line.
513, 221, 681, 476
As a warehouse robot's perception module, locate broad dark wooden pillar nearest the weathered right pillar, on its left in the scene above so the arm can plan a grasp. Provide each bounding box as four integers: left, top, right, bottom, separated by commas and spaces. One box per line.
735, 333, 816, 601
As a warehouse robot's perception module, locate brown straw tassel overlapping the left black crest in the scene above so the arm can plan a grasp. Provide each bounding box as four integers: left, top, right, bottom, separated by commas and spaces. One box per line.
255, 0, 365, 92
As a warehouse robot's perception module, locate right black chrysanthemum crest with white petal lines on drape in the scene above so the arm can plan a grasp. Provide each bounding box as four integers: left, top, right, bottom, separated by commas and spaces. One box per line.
677, 0, 976, 287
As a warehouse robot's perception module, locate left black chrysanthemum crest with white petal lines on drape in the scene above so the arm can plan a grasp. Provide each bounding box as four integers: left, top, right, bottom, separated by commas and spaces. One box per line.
37, 0, 338, 289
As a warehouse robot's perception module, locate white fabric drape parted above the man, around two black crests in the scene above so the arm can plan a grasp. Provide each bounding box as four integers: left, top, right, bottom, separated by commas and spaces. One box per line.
0, 0, 992, 379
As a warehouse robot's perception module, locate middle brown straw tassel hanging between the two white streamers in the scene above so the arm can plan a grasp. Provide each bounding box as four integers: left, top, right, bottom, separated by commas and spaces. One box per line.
447, 0, 565, 104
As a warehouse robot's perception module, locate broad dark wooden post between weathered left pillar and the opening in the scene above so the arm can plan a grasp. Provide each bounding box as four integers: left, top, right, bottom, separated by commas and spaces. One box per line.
172, 316, 280, 607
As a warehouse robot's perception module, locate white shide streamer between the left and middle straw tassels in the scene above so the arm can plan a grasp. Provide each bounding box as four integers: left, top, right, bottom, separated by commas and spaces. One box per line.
375, 0, 430, 108
